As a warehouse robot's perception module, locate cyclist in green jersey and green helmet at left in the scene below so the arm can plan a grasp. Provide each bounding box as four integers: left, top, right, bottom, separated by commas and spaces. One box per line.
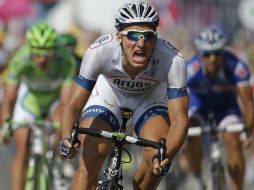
1, 21, 76, 190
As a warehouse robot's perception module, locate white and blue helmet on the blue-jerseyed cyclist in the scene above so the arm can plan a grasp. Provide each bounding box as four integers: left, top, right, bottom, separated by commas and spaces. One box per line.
195, 27, 226, 51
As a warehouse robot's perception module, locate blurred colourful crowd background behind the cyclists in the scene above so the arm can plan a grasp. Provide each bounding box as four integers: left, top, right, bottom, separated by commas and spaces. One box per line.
0, 0, 254, 190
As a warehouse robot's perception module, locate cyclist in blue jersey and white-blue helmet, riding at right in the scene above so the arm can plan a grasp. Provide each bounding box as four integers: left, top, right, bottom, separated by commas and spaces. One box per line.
187, 26, 254, 190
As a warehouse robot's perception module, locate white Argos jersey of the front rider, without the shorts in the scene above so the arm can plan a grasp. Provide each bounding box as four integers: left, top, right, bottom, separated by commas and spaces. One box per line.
79, 34, 186, 93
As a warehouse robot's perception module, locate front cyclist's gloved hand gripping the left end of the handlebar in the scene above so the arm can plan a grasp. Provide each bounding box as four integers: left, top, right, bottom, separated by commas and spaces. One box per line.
60, 138, 80, 159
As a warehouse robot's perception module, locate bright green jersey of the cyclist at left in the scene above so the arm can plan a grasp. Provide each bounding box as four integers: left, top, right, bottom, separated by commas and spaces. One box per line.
7, 45, 77, 107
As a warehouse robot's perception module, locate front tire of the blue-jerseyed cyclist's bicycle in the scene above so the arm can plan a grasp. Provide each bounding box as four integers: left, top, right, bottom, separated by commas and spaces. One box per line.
212, 163, 227, 190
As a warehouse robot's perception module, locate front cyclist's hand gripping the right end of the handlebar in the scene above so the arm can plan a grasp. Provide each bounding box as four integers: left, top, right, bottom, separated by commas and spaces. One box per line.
153, 157, 172, 176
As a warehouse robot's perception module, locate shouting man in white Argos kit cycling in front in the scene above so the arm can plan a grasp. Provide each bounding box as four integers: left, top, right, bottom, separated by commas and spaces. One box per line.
60, 2, 188, 190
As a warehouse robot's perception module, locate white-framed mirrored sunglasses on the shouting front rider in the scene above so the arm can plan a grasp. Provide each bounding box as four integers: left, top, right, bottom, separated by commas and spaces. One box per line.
120, 30, 157, 42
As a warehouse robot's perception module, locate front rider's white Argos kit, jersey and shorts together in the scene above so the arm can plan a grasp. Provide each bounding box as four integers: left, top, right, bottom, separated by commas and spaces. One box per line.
76, 34, 187, 133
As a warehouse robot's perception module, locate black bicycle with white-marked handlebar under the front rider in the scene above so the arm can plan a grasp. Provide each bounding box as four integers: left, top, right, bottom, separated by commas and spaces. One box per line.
70, 108, 166, 190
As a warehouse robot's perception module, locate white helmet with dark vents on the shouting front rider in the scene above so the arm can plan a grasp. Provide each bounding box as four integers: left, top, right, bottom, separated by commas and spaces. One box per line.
115, 1, 159, 31
